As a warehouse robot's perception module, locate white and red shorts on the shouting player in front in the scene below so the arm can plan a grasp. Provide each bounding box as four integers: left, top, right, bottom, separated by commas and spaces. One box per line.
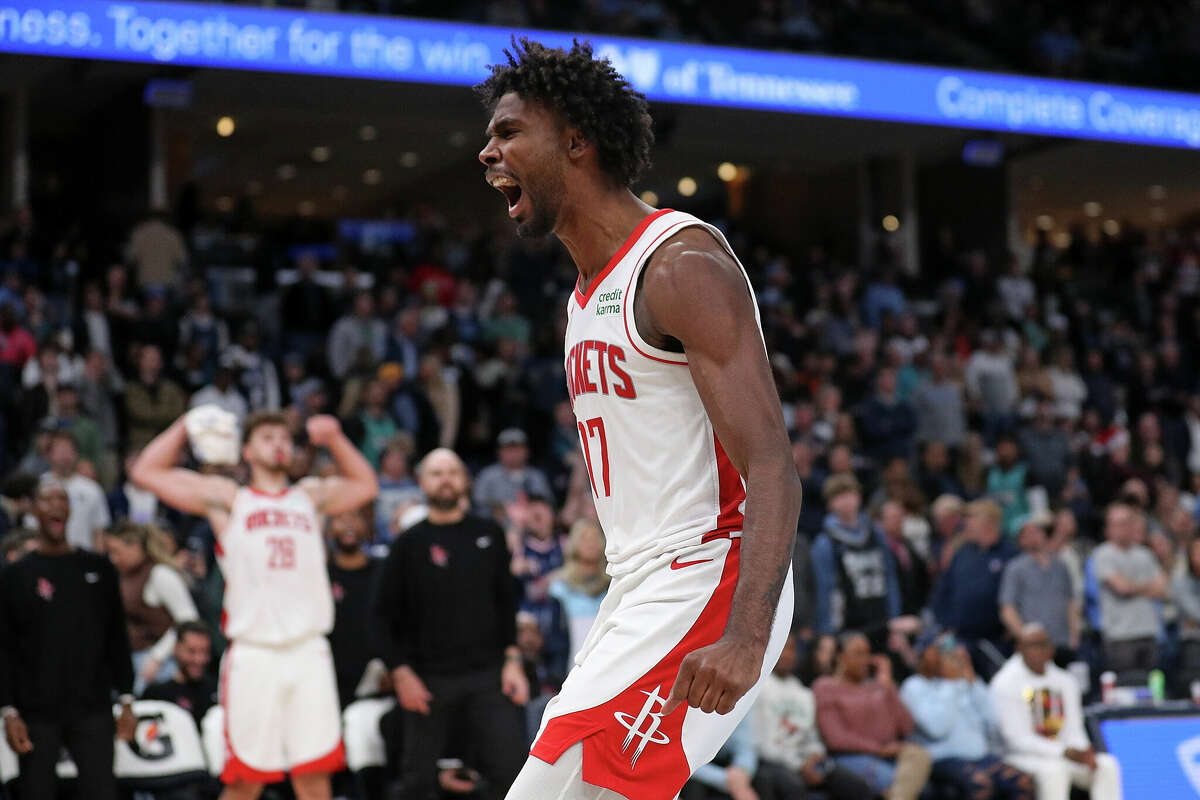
523, 537, 793, 800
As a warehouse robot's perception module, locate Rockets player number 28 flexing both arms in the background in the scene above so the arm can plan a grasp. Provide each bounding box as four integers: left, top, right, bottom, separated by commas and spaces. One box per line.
130, 407, 378, 800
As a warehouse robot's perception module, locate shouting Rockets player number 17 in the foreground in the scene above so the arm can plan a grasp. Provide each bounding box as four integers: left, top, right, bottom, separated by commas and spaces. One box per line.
478, 40, 800, 800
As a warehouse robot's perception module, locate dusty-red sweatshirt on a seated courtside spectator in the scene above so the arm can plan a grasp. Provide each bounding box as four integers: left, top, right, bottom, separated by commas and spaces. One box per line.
812, 676, 913, 756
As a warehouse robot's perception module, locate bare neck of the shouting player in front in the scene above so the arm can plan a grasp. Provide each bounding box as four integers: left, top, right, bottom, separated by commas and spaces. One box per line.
554, 190, 654, 290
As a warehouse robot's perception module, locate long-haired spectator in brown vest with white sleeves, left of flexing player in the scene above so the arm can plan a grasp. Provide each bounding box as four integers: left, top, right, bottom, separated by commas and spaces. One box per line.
104, 522, 199, 692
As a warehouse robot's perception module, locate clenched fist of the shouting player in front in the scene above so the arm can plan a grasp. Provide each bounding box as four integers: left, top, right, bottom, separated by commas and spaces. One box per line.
664, 638, 762, 714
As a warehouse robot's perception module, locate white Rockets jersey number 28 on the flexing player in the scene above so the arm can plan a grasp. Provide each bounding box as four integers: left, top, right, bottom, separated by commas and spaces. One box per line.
217, 486, 334, 645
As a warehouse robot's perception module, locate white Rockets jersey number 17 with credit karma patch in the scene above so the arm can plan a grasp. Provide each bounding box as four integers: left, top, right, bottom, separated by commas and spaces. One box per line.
565, 209, 761, 576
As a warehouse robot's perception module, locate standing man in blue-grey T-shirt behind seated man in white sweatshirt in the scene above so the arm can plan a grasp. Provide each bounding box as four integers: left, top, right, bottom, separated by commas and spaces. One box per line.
1000, 511, 1082, 667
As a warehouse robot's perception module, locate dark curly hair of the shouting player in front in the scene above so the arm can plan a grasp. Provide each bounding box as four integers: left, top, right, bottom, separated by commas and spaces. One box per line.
475, 37, 654, 186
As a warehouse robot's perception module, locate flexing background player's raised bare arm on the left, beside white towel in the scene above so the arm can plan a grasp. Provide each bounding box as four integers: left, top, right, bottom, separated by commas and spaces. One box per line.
130, 417, 238, 535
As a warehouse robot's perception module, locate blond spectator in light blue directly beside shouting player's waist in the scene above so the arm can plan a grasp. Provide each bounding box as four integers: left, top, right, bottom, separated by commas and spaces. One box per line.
548, 519, 612, 664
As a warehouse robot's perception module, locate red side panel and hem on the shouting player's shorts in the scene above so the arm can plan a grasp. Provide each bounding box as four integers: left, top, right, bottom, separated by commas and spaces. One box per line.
530, 539, 742, 800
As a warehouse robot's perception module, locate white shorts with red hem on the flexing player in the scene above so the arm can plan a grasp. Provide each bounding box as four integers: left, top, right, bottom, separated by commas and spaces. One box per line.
221, 636, 346, 783
